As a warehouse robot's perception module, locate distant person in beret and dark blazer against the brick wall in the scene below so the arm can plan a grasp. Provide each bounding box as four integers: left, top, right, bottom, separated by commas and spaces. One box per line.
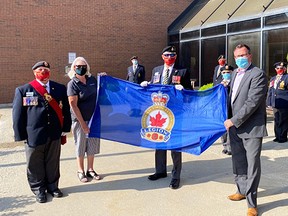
126, 56, 145, 84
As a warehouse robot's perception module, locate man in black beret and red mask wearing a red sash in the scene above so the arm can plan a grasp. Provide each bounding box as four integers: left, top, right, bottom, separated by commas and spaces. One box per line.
13, 61, 71, 203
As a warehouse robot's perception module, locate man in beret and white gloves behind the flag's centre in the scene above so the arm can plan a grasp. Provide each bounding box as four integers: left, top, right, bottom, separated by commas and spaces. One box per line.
140, 46, 192, 189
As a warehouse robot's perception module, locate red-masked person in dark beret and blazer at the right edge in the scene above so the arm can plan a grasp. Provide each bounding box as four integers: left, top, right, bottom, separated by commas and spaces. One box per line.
266, 62, 288, 143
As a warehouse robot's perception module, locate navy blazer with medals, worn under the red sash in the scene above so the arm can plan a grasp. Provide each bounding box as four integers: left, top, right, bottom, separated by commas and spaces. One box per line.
12, 81, 71, 147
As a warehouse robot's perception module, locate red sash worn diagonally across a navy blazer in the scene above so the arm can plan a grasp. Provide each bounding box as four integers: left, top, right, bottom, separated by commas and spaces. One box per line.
29, 80, 63, 128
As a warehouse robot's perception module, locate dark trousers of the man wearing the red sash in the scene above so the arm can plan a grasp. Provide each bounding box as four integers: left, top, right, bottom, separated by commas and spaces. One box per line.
25, 138, 61, 194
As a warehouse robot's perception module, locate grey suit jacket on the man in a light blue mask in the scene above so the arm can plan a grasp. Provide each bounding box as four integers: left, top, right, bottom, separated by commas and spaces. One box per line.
228, 64, 268, 138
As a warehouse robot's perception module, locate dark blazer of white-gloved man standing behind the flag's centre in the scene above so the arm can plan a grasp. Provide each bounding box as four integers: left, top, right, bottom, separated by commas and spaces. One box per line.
150, 65, 193, 90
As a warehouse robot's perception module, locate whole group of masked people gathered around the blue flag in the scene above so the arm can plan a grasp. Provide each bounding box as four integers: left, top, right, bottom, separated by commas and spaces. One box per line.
13, 44, 288, 216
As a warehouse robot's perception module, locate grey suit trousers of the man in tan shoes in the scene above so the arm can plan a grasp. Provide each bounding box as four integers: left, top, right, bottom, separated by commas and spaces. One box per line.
229, 126, 263, 208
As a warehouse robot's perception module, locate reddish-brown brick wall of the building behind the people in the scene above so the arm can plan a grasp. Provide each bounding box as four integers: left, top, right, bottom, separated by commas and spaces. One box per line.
0, 0, 191, 104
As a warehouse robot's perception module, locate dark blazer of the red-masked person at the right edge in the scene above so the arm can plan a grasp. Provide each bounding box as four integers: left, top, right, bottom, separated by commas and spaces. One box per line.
266, 74, 288, 109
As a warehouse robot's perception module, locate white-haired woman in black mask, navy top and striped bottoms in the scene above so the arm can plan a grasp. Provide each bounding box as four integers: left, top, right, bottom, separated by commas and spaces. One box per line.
67, 57, 101, 183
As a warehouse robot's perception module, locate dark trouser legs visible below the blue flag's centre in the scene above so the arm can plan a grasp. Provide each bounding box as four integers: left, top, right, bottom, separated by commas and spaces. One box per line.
155, 150, 182, 179
